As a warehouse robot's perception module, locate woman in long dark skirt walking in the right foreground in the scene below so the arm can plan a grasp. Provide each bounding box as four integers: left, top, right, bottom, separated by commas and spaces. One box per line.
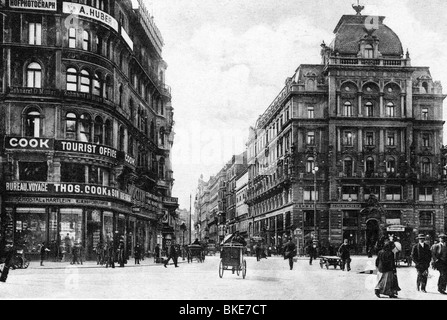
374, 240, 400, 298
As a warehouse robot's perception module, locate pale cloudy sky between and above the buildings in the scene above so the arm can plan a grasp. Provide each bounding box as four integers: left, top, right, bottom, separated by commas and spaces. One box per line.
146, 0, 447, 209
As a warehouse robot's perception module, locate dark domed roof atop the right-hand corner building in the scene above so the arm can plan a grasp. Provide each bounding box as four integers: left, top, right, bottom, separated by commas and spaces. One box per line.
331, 15, 404, 57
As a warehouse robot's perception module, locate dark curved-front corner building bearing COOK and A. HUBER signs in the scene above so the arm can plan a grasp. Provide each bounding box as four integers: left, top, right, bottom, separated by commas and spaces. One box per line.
0, 0, 178, 258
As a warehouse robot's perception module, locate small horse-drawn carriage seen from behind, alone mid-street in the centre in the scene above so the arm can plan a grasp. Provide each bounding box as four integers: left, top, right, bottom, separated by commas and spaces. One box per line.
219, 243, 247, 279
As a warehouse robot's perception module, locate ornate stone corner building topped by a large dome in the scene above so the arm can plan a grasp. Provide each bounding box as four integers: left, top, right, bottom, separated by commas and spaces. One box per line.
247, 8, 446, 253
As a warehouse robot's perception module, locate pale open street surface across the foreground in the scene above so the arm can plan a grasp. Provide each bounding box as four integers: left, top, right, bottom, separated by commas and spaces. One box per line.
0, 255, 447, 300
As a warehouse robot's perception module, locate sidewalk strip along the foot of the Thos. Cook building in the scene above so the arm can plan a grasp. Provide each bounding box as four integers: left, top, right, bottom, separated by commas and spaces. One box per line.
28, 257, 188, 269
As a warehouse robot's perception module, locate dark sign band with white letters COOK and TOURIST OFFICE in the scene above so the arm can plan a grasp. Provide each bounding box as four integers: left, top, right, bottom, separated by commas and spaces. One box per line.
5, 136, 135, 166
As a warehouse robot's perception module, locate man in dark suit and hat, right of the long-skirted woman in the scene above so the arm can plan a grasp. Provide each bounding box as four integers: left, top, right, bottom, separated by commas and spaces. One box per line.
411, 234, 432, 292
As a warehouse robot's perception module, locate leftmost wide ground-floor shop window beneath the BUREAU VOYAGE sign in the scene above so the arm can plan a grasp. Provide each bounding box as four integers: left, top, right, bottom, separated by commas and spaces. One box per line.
15, 207, 47, 254
